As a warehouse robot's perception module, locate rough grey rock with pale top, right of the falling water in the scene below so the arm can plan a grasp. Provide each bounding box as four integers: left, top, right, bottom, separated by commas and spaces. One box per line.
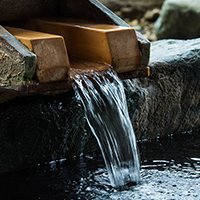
124, 39, 200, 139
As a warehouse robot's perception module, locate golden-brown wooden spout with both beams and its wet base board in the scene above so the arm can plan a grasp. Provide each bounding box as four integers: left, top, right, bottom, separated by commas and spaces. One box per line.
1, 17, 149, 93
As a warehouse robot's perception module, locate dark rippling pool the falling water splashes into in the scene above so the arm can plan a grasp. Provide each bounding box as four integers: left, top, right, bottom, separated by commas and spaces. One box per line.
0, 132, 200, 200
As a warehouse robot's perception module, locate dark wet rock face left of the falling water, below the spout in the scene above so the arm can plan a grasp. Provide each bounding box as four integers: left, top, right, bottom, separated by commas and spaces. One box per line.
0, 90, 92, 172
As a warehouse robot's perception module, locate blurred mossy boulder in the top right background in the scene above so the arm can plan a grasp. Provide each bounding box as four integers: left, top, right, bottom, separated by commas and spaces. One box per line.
155, 0, 200, 39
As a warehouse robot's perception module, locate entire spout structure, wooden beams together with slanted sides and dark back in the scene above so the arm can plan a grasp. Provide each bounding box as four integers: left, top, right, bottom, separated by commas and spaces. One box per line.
0, 0, 150, 94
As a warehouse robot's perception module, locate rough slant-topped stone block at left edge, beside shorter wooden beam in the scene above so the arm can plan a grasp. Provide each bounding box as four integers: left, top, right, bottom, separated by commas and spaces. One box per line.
0, 26, 36, 87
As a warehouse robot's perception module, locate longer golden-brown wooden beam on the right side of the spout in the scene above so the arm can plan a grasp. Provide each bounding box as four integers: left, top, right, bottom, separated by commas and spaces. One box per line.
27, 18, 142, 73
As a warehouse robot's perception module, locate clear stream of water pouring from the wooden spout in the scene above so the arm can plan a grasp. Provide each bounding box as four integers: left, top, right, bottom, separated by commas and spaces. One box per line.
73, 70, 140, 188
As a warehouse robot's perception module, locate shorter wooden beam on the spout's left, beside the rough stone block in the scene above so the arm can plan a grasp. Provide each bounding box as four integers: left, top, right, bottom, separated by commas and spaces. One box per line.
5, 27, 70, 83
